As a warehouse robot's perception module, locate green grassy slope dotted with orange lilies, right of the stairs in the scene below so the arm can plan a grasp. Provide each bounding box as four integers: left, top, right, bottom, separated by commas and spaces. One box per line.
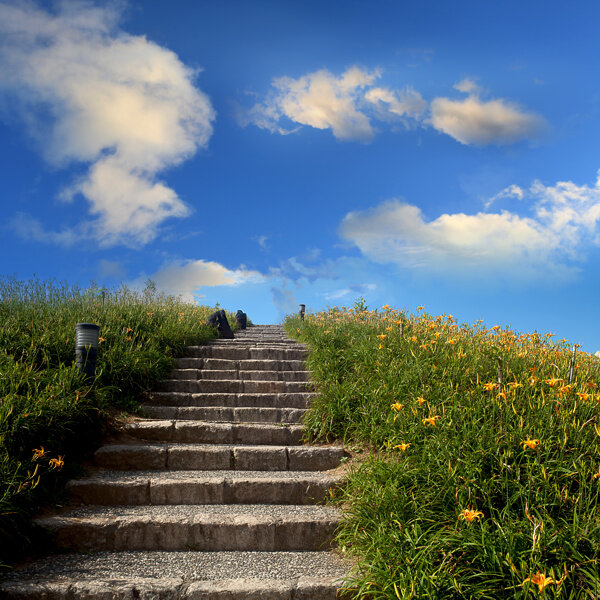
286, 303, 600, 599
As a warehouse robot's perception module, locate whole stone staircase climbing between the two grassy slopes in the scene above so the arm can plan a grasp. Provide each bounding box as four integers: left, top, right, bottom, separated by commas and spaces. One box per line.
0, 325, 349, 600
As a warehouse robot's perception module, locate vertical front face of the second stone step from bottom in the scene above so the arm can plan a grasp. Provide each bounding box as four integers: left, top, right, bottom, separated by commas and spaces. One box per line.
38, 518, 338, 552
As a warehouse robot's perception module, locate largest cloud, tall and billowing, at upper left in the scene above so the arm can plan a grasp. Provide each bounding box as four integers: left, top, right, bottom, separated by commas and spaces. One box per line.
0, 2, 215, 245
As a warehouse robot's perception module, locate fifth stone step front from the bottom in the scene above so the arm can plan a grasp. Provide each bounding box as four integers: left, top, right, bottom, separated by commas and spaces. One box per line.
122, 421, 304, 446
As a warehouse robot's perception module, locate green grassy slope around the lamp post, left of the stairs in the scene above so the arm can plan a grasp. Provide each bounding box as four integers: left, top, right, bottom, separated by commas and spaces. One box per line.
0, 277, 244, 566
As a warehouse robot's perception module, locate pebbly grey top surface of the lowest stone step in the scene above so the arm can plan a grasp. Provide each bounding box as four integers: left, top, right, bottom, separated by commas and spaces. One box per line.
0, 551, 351, 590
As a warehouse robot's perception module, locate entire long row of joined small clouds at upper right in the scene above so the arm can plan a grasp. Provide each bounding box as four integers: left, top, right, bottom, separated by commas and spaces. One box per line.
237, 66, 545, 145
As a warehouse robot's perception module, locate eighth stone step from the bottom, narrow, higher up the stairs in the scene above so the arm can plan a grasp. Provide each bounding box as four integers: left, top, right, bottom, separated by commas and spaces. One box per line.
158, 379, 314, 394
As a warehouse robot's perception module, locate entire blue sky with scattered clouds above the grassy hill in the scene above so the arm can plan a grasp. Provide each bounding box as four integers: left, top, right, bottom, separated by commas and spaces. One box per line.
0, 0, 600, 352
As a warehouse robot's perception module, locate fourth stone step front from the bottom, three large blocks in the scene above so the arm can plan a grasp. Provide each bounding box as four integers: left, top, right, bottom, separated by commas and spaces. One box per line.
94, 444, 344, 471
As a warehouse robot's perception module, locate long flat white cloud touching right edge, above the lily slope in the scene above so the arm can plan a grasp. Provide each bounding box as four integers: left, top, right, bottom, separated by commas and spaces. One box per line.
341, 170, 600, 277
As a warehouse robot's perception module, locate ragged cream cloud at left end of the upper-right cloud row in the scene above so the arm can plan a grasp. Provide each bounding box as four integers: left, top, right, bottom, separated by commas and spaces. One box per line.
240, 67, 379, 141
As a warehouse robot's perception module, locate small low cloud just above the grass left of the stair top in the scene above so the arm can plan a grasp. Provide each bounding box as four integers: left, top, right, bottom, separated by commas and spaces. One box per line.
132, 260, 265, 302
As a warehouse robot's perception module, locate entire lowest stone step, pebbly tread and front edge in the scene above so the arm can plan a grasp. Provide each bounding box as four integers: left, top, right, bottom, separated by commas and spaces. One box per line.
0, 551, 351, 600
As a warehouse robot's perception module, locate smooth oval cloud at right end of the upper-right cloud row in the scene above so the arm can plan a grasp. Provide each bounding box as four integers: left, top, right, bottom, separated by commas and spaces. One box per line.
429, 95, 545, 145
